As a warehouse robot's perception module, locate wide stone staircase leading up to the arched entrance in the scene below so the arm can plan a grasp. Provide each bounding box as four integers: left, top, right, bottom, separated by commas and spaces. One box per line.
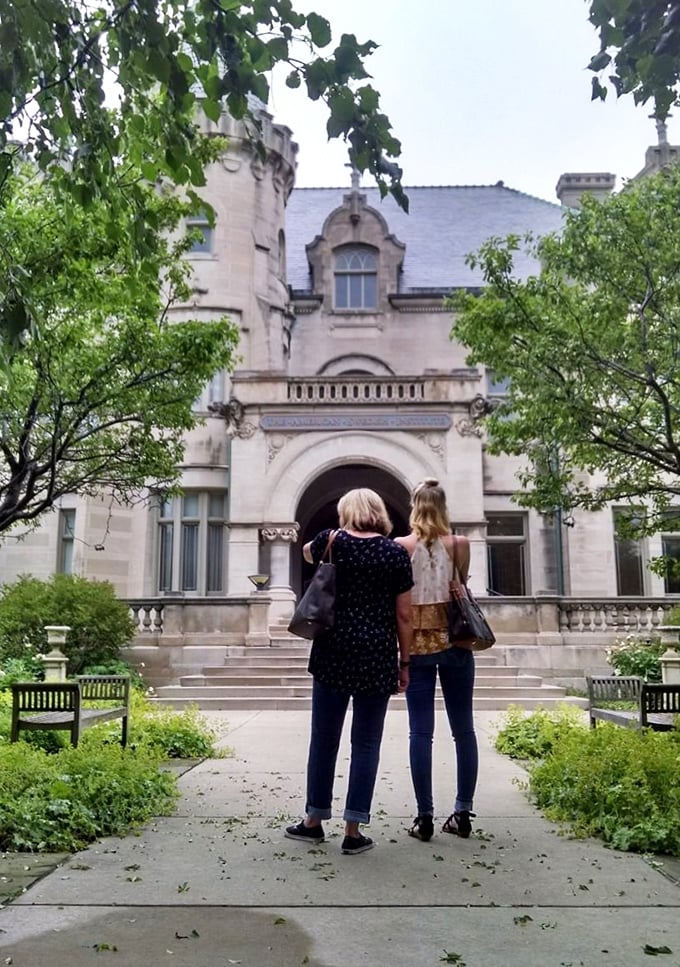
156, 636, 585, 711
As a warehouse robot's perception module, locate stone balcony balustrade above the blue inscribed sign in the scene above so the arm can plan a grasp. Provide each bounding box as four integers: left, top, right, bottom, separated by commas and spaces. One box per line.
288, 376, 427, 404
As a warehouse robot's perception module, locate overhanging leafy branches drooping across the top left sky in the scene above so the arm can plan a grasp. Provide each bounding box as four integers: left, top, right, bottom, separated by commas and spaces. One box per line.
0, 0, 405, 212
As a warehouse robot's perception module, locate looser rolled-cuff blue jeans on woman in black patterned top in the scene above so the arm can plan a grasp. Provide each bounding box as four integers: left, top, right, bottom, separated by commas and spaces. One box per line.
305, 679, 390, 823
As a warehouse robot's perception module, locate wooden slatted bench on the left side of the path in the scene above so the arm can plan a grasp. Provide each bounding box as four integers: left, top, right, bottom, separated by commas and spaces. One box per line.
10, 675, 130, 747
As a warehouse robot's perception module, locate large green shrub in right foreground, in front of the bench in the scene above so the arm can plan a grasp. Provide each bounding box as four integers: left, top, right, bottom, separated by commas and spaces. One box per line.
530, 723, 680, 856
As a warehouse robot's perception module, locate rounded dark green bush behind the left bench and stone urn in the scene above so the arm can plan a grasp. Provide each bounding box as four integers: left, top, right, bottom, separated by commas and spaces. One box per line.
0, 574, 135, 675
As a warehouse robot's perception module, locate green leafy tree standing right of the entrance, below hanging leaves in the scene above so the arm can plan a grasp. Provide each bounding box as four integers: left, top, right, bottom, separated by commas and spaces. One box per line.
452, 168, 680, 533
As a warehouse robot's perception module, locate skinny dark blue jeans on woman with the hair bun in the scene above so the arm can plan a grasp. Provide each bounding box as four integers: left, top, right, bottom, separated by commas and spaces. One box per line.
406, 648, 479, 816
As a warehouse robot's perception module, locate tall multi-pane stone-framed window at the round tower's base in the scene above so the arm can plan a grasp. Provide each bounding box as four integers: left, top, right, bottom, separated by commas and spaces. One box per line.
158, 491, 225, 594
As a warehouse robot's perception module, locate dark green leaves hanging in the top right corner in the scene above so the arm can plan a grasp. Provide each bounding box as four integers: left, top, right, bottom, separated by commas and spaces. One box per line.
588, 0, 680, 121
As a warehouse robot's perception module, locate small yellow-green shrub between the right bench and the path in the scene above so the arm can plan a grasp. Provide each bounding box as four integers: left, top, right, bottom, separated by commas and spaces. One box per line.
495, 705, 584, 759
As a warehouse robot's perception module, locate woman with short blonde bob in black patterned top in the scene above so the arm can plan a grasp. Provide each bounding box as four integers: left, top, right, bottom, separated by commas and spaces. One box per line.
285, 487, 413, 855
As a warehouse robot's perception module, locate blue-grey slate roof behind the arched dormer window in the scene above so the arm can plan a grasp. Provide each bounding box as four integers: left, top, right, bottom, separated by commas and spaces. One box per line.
286, 183, 566, 292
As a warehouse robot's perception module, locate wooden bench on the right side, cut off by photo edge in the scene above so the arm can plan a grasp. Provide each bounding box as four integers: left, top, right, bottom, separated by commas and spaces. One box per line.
586, 675, 680, 732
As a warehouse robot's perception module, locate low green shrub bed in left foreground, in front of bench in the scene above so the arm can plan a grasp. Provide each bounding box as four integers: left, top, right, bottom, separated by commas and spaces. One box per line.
0, 742, 177, 852
